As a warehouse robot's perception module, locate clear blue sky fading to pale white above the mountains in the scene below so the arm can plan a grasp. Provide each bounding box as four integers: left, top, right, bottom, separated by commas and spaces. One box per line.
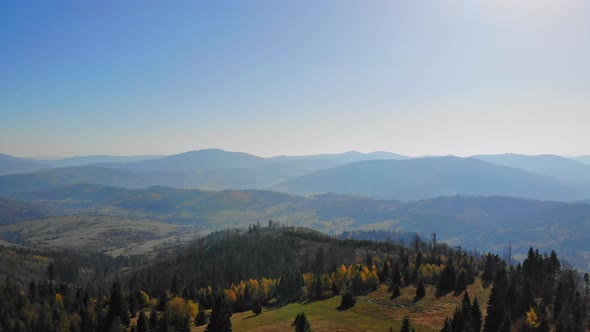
0, 0, 590, 157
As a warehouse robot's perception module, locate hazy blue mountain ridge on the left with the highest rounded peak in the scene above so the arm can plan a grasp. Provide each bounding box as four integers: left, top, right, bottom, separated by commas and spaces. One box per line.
0, 149, 416, 196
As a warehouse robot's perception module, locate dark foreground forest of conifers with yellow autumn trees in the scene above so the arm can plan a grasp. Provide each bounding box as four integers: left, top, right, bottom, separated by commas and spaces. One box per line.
0, 227, 590, 332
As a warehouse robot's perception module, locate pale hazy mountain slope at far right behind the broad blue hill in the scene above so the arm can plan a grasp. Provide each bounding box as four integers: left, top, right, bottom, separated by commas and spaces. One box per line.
473, 154, 590, 184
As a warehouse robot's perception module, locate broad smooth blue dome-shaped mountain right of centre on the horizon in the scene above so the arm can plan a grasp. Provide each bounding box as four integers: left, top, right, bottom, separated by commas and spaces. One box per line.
273, 157, 584, 201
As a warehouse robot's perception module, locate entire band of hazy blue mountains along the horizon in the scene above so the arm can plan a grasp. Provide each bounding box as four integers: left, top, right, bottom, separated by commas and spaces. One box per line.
0, 149, 590, 201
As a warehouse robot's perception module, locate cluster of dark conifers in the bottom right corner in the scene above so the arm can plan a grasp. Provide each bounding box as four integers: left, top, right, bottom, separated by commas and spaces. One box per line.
441, 248, 590, 332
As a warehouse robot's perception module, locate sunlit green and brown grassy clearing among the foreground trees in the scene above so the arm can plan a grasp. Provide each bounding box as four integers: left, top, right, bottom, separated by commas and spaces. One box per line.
192, 279, 491, 332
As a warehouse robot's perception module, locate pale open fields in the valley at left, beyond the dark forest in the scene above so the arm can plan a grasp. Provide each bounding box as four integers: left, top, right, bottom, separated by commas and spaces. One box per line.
0, 215, 200, 255
